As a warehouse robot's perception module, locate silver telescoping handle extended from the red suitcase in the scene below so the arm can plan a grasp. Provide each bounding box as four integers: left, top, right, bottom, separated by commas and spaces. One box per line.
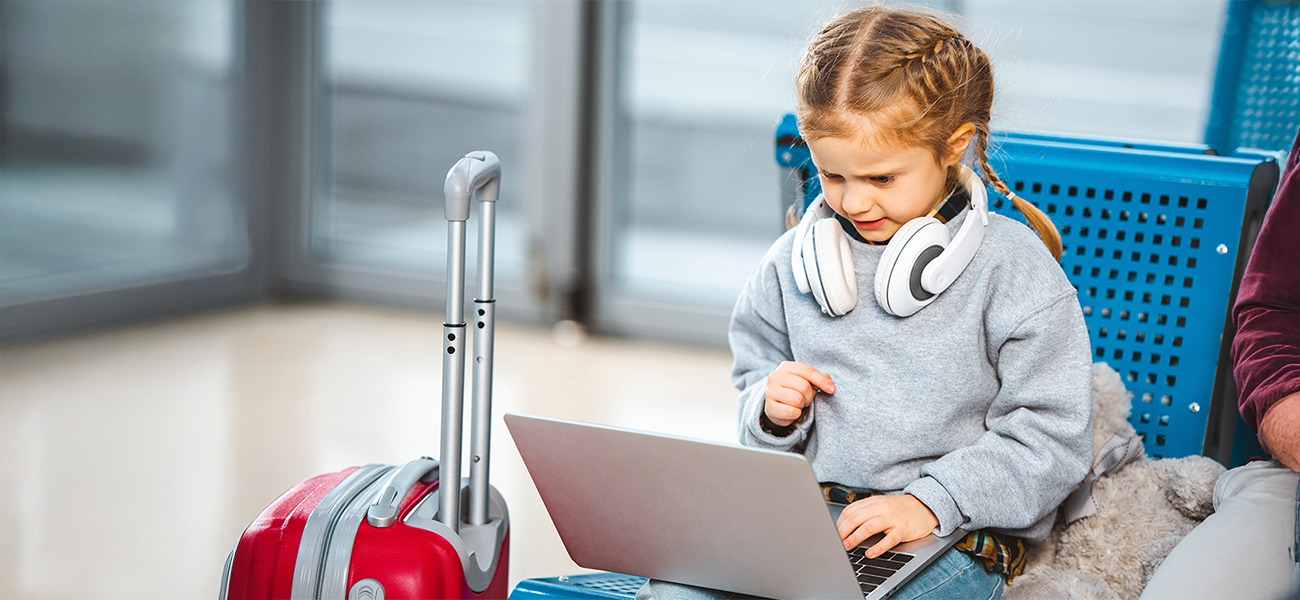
438, 151, 501, 532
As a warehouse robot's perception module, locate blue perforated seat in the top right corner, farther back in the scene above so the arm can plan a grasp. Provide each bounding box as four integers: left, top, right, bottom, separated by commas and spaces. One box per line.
1205, 0, 1300, 151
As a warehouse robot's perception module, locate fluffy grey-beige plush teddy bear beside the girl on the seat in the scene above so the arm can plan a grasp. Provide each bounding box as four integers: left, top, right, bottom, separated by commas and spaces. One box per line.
1002, 362, 1225, 600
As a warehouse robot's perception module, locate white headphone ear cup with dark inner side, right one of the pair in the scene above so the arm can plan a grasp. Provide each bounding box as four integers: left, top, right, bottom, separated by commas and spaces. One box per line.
875, 217, 952, 317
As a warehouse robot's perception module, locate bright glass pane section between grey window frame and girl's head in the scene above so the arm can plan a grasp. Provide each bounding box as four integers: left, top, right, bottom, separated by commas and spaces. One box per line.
612, 0, 857, 305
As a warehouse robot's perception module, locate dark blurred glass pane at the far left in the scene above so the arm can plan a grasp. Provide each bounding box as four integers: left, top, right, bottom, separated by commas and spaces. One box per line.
0, 0, 250, 305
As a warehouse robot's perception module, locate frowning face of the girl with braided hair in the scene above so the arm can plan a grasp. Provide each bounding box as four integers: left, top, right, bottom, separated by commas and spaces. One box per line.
809, 119, 974, 243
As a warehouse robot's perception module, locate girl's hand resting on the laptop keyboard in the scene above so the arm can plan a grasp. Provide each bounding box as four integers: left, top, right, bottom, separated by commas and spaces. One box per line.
835, 494, 939, 558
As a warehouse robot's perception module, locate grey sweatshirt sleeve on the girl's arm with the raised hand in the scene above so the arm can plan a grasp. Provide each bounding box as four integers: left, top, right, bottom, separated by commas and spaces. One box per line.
728, 249, 813, 451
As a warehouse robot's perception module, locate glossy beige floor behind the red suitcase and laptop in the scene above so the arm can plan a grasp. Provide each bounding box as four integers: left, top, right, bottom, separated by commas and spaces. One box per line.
0, 305, 735, 600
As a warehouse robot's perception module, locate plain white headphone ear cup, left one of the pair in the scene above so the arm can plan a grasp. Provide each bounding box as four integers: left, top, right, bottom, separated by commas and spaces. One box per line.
803, 218, 858, 317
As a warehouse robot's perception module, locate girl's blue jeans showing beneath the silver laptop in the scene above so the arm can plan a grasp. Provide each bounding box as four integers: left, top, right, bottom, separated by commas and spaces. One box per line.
637, 548, 1006, 600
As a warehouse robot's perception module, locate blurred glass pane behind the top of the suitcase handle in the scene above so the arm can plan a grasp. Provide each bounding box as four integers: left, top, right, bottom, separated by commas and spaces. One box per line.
312, 0, 530, 281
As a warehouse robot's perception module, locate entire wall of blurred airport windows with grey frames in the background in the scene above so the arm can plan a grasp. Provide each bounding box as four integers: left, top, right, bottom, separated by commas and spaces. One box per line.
0, 0, 1227, 344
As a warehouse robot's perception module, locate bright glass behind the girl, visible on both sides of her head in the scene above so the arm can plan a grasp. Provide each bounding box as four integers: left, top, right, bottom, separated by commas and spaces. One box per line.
610, 0, 1226, 314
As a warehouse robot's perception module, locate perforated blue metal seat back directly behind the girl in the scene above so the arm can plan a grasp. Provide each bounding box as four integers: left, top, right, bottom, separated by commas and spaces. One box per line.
777, 117, 1278, 464
